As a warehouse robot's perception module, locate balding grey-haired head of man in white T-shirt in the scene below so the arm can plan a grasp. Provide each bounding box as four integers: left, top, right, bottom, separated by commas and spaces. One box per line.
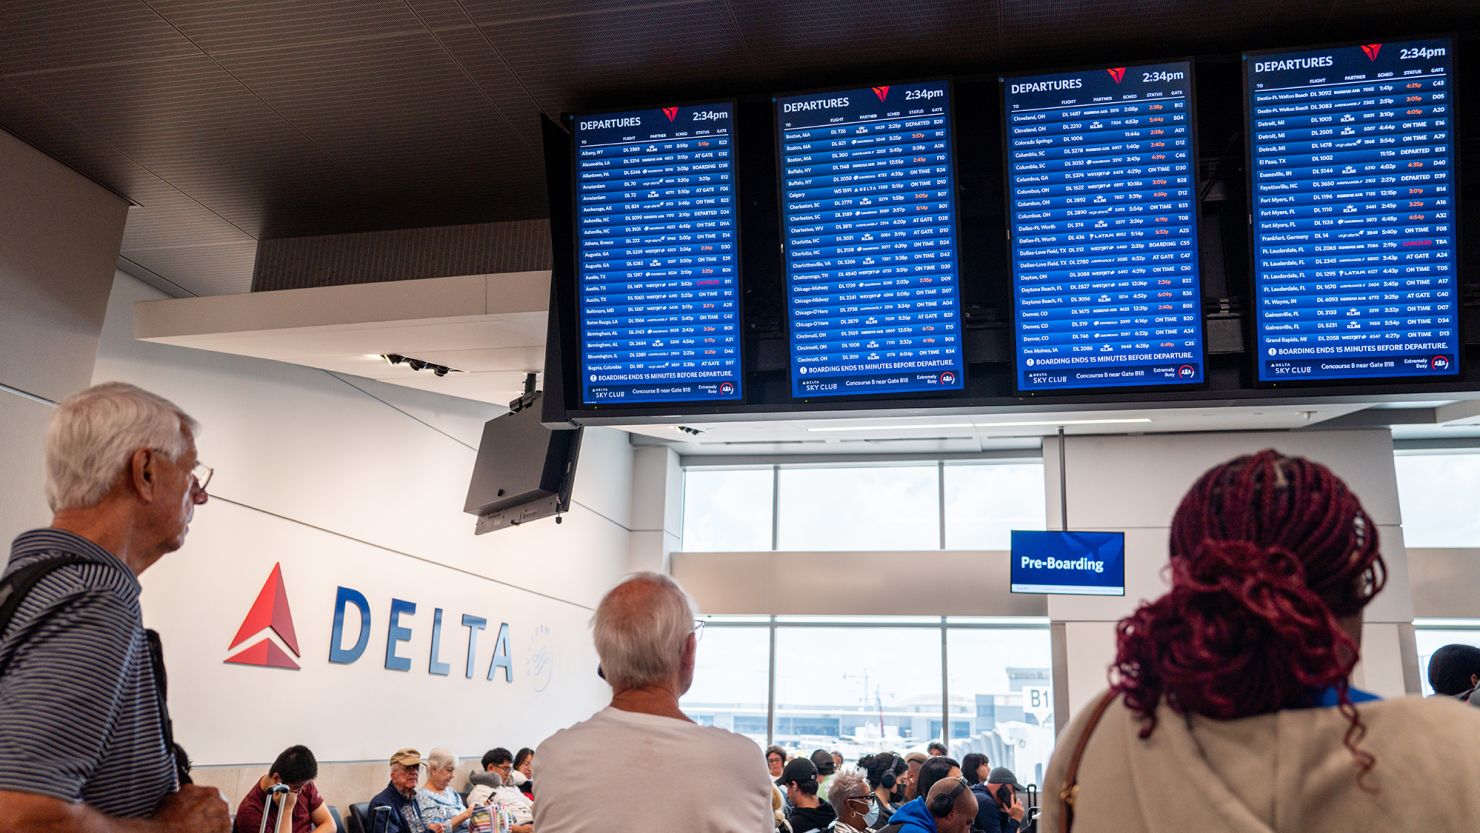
591, 573, 694, 689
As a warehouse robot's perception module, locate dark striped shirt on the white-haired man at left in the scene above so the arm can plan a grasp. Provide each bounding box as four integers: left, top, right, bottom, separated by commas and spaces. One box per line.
0, 528, 179, 818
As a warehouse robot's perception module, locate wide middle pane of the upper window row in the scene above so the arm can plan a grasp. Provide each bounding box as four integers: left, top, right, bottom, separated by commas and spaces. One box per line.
777, 465, 940, 552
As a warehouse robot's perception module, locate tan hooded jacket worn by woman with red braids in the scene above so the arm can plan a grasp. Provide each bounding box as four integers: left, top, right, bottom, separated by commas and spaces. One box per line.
1040, 697, 1480, 833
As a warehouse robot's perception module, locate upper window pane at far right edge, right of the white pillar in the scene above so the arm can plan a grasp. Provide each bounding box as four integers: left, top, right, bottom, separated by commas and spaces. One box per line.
1394, 451, 1480, 547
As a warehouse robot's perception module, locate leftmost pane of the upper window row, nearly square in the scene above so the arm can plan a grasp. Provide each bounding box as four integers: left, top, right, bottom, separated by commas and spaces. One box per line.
684, 466, 776, 552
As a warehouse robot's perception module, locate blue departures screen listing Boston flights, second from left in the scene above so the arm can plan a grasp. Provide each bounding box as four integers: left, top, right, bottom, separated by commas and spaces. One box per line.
776, 81, 963, 398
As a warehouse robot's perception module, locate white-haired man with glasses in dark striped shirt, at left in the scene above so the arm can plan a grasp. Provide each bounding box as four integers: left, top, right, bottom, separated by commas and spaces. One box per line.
0, 383, 229, 833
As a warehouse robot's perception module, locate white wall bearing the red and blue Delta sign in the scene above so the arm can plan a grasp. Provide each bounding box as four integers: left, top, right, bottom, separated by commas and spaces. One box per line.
86, 274, 632, 787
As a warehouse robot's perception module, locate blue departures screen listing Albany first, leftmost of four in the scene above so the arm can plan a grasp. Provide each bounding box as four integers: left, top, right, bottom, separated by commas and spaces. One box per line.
573, 102, 741, 405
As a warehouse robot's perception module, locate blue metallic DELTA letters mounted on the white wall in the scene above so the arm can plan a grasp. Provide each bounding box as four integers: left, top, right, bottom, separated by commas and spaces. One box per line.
329, 587, 514, 682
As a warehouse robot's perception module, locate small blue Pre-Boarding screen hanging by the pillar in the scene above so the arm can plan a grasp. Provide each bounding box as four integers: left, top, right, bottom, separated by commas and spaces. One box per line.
1009, 530, 1125, 596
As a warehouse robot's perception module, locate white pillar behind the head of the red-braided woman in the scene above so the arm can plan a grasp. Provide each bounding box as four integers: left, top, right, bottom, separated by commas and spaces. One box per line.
1043, 431, 1418, 726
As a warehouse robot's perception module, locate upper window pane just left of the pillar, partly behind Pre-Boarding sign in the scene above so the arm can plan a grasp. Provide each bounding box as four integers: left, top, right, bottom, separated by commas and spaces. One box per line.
944, 462, 1046, 549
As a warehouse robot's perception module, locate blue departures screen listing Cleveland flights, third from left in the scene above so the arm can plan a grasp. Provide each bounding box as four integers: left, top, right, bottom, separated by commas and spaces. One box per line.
1002, 61, 1205, 392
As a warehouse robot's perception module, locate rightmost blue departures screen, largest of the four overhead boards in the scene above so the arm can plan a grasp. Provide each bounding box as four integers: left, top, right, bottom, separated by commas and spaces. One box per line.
1245, 38, 1459, 382
